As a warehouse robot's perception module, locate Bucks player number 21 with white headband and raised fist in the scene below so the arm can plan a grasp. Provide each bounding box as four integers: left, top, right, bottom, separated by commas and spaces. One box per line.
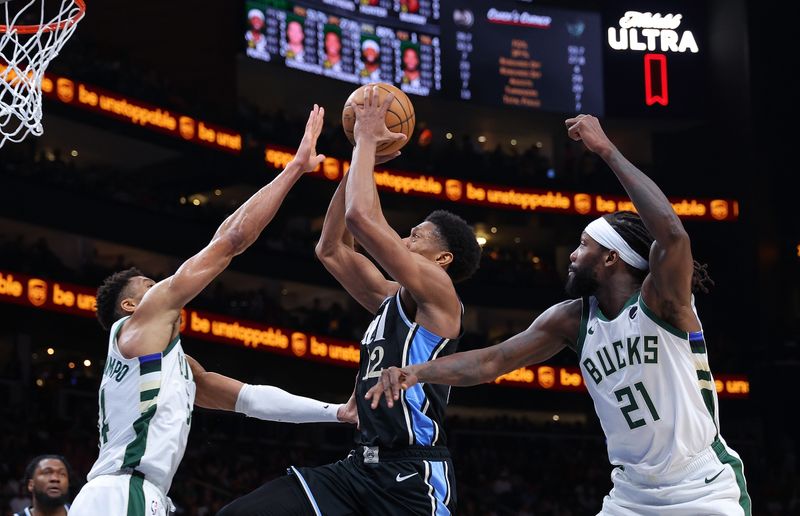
362, 115, 751, 516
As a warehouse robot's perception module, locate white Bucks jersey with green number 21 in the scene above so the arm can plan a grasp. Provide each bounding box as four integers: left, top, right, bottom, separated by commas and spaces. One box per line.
578, 292, 719, 475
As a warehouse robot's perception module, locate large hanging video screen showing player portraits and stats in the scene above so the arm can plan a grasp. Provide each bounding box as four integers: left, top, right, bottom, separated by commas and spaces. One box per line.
244, 0, 603, 114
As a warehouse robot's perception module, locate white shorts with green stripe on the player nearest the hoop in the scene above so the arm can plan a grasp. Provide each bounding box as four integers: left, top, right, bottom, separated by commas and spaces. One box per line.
69, 474, 175, 516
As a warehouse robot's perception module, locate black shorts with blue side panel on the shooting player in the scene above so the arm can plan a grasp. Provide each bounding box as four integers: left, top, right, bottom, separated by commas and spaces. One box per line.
289, 447, 456, 516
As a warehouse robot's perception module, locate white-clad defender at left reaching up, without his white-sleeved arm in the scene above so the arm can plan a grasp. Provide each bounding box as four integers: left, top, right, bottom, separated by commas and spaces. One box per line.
70, 105, 324, 516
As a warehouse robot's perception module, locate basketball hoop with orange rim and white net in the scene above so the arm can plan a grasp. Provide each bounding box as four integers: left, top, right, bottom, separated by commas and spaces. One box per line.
0, 0, 86, 147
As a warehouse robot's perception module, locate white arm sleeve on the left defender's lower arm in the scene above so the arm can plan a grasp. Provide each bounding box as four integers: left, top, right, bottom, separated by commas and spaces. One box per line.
236, 384, 341, 423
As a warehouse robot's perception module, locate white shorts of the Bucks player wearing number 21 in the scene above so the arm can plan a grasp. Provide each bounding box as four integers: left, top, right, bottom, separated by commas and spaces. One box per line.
600, 441, 751, 516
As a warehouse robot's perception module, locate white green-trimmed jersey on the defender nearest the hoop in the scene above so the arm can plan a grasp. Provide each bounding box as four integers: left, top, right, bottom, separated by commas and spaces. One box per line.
87, 317, 195, 494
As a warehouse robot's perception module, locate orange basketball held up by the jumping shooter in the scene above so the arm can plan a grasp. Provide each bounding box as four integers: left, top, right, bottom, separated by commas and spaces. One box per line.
342, 82, 415, 156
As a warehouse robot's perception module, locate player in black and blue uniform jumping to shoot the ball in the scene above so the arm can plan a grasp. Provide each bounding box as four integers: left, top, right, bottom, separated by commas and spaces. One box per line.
219, 87, 480, 516
